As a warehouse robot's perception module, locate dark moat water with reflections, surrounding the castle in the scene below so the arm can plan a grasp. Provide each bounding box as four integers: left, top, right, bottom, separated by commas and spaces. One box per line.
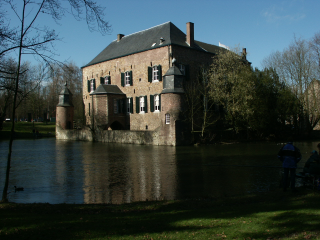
0, 138, 318, 204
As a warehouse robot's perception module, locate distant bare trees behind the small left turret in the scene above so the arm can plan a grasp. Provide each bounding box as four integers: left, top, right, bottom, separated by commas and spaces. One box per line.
0, 58, 83, 126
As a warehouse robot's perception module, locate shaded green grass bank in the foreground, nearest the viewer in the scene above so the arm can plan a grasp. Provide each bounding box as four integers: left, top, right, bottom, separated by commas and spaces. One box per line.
0, 189, 320, 240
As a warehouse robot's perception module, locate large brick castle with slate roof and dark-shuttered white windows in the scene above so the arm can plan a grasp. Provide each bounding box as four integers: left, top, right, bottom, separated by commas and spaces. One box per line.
57, 22, 242, 145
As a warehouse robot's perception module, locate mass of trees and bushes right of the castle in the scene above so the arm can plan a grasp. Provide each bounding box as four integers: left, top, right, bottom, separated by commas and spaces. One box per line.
185, 32, 320, 142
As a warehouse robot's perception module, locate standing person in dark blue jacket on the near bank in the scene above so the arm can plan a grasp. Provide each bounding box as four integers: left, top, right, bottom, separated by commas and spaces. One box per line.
278, 142, 301, 191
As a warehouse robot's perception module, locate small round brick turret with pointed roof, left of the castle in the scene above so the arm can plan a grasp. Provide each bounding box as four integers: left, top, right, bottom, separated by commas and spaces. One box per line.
56, 83, 74, 130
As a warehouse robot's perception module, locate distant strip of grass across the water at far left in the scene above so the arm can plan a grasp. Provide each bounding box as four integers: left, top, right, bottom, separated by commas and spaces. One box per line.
0, 122, 56, 140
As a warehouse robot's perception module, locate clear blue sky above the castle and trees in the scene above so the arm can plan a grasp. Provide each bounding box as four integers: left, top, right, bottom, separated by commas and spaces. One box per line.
2, 0, 320, 69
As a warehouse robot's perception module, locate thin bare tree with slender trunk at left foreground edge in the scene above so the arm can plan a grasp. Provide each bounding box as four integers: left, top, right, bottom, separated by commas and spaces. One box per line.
0, 0, 110, 202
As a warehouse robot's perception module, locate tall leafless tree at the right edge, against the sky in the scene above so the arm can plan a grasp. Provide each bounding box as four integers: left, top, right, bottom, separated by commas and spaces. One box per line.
262, 38, 320, 132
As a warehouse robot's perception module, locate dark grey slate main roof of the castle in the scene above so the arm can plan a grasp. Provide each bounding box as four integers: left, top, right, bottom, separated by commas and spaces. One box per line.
83, 22, 221, 67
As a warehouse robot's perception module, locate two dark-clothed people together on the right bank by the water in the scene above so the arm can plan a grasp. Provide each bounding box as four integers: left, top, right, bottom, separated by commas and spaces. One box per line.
278, 141, 320, 191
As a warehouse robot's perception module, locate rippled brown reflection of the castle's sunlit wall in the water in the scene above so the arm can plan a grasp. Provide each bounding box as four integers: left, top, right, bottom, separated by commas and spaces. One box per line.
82, 143, 177, 204
